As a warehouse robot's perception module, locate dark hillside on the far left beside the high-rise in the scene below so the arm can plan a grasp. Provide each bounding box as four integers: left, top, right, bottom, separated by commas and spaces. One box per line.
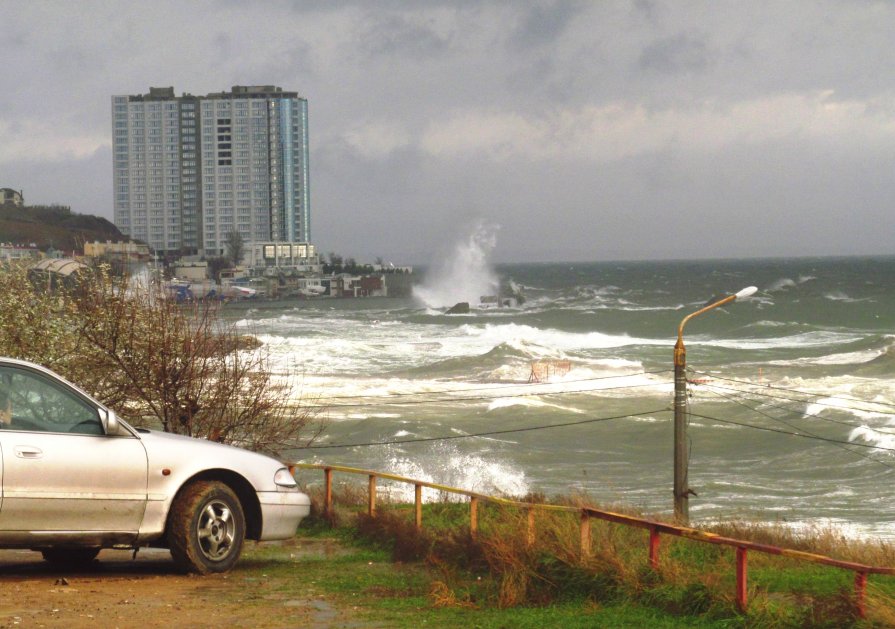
0, 203, 126, 251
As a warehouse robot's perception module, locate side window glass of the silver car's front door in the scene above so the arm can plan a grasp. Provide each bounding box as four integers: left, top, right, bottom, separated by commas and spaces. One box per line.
0, 367, 104, 435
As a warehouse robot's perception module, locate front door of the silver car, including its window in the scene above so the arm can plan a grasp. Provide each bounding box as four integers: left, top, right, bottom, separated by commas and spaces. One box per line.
0, 363, 147, 539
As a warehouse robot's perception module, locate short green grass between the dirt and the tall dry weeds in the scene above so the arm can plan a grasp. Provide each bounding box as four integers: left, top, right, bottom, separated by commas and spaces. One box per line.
240, 530, 741, 629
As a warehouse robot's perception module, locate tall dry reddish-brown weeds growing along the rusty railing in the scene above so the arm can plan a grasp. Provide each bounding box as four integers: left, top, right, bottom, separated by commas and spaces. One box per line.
300, 486, 895, 627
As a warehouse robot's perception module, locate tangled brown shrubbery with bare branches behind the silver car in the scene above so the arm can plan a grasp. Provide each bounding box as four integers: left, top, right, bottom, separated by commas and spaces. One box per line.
0, 267, 322, 454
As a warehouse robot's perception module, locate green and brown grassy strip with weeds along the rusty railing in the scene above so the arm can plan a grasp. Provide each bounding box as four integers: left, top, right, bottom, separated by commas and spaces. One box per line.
272, 496, 895, 628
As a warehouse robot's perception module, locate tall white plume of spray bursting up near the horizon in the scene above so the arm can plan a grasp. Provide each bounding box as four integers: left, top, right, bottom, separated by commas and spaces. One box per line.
413, 221, 499, 308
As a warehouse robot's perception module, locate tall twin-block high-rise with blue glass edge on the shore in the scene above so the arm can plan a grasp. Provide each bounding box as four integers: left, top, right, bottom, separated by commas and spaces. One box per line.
112, 85, 311, 255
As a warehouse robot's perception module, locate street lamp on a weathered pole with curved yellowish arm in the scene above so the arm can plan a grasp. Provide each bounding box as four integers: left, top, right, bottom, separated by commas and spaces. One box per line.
674, 286, 758, 524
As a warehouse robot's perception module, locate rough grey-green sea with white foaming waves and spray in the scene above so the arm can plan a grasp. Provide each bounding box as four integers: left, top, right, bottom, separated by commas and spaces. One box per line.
227, 248, 895, 539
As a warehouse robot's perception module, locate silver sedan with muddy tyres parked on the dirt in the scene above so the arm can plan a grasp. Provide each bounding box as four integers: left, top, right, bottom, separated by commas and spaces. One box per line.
0, 358, 310, 573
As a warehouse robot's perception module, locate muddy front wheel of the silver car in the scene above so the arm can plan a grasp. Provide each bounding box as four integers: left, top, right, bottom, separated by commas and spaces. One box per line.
168, 481, 245, 574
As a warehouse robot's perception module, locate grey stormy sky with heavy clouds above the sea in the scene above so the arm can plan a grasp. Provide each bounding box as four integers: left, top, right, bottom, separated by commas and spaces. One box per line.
0, 0, 895, 263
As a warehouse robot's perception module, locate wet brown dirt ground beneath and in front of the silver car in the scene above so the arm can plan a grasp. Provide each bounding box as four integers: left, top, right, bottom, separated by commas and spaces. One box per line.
0, 540, 369, 628
